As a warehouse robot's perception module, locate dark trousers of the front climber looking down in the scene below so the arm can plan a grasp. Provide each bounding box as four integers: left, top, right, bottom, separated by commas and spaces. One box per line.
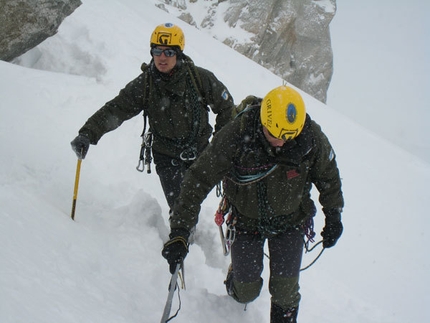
231, 230, 303, 309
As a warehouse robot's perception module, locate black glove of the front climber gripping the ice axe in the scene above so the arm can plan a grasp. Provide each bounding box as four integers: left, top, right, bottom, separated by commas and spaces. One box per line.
161, 229, 190, 274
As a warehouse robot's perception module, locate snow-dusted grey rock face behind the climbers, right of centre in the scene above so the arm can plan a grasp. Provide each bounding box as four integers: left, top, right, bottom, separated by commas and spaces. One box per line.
164, 0, 336, 102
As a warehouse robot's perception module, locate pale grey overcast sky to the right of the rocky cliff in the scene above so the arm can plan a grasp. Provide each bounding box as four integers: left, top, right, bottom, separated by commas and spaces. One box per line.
327, 0, 430, 162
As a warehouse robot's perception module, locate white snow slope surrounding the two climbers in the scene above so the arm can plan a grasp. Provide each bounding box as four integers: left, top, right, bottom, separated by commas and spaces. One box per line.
0, 0, 430, 323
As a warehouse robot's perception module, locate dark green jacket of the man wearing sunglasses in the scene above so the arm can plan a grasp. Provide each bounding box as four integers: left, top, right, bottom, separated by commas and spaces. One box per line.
79, 55, 234, 158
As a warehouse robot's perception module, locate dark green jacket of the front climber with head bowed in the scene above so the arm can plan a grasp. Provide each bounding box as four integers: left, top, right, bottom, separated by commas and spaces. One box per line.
170, 107, 344, 234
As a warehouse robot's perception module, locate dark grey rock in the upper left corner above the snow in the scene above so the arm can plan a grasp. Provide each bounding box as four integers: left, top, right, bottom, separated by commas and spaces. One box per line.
0, 0, 82, 61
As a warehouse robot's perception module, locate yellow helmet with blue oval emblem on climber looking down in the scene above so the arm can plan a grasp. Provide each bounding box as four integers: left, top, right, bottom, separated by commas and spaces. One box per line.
260, 85, 306, 140
